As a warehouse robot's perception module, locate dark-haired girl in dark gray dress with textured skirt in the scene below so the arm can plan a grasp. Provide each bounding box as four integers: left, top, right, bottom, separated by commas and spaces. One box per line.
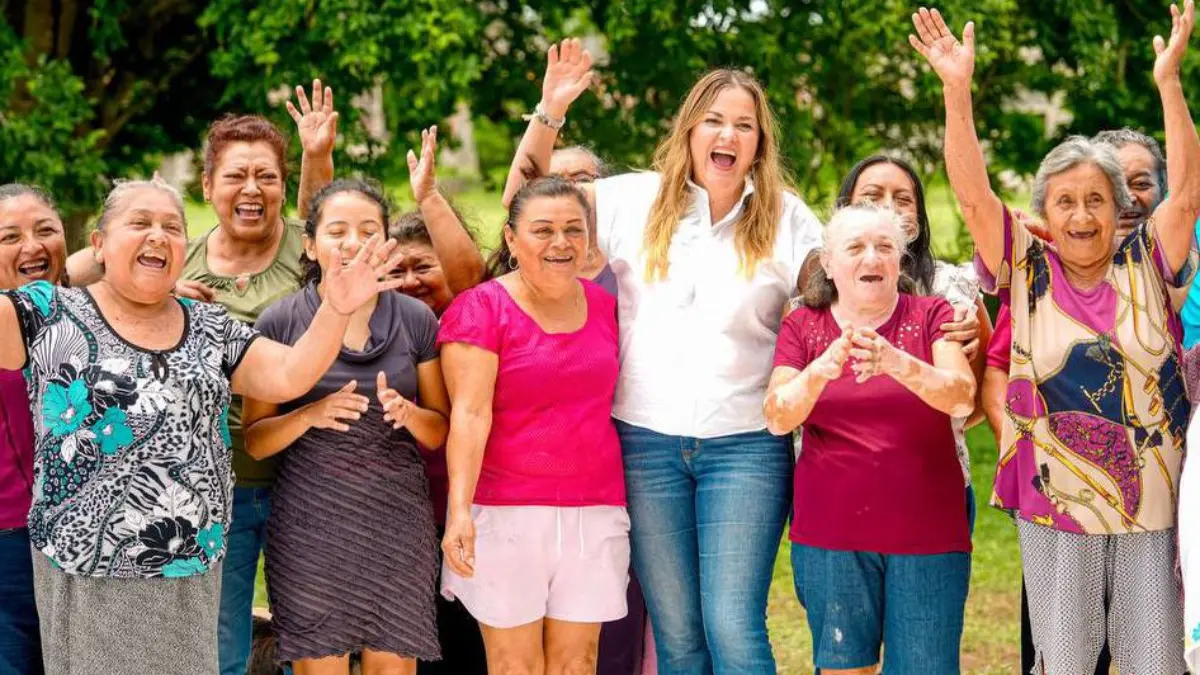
246, 181, 449, 671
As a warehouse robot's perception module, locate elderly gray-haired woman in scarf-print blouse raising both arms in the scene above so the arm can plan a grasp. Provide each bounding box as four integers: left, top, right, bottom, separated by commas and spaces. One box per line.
910, 0, 1200, 675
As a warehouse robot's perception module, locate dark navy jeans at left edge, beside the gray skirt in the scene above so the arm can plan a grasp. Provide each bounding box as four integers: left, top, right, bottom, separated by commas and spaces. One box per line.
0, 527, 42, 675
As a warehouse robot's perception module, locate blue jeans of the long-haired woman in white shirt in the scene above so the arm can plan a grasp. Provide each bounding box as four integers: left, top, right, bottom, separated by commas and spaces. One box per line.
617, 422, 792, 675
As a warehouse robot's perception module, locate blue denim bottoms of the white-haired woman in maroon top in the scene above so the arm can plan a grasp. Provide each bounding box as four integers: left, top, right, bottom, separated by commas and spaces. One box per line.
792, 544, 971, 675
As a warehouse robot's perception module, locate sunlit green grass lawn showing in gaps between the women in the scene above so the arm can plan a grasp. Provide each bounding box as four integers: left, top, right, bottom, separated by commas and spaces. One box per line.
187, 185, 1020, 675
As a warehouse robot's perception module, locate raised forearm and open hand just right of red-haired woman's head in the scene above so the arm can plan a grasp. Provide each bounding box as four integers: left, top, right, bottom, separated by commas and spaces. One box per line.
287, 79, 337, 219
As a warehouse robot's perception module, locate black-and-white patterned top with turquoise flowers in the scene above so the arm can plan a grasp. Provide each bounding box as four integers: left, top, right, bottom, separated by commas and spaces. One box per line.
5, 281, 258, 578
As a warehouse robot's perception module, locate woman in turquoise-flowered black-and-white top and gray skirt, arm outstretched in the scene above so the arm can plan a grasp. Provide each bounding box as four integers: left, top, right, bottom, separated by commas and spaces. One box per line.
0, 179, 398, 675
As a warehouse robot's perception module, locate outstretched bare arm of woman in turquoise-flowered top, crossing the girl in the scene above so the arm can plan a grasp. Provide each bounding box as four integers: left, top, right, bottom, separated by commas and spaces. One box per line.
232, 234, 401, 404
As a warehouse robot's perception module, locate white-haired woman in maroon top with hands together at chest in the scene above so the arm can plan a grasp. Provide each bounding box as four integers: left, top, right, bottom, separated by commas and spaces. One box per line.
764, 205, 976, 674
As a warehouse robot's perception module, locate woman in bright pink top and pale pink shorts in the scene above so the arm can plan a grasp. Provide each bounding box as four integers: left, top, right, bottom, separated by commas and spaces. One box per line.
438, 177, 629, 673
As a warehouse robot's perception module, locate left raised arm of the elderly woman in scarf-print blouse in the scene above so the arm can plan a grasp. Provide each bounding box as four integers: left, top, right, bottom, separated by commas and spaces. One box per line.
908, 7, 1004, 274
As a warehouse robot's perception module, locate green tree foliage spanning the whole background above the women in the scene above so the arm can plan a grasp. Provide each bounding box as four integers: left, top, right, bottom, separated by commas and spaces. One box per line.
0, 0, 1198, 248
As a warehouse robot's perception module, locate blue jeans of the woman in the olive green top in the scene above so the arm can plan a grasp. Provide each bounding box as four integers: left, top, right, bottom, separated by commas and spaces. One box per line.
217, 488, 271, 675
